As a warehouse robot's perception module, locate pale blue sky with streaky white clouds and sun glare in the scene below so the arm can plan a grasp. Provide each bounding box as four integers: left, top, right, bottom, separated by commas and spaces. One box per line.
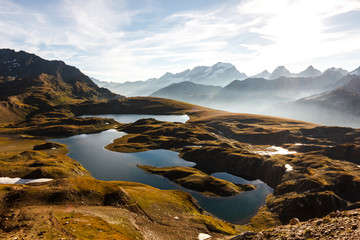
0, 0, 360, 82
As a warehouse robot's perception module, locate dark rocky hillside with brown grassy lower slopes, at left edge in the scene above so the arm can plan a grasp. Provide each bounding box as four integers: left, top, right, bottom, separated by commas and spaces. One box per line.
0, 49, 121, 122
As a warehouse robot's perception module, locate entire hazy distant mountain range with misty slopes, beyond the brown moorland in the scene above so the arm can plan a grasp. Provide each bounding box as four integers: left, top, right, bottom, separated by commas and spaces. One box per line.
96, 63, 360, 127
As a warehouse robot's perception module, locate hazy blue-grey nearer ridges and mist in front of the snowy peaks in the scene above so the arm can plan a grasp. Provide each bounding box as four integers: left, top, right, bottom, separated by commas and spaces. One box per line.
151, 66, 360, 127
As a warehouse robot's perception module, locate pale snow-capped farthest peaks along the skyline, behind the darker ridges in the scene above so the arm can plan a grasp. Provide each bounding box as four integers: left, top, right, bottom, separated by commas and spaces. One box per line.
97, 62, 348, 96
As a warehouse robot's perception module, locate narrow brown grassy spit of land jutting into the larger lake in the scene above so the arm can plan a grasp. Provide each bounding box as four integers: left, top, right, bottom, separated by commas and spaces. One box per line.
138, 165, 255, 197
